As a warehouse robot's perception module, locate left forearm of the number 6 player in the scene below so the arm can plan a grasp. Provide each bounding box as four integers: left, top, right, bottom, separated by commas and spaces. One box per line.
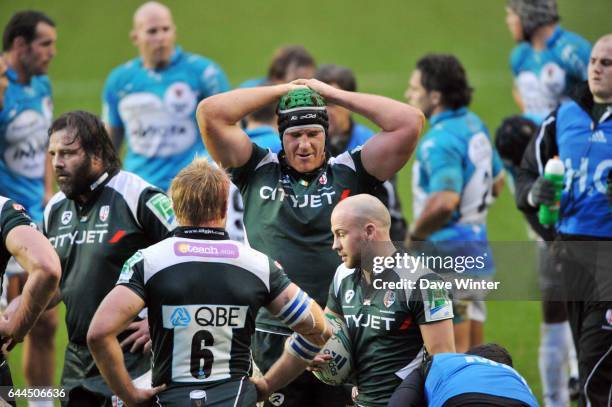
87, 330, 136, 405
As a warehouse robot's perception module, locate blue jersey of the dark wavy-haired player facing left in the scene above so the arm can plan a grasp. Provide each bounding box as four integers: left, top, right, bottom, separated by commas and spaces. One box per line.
412, 107, 502, 241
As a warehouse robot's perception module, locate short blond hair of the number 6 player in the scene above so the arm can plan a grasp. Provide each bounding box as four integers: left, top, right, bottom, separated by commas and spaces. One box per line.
170, 158, 230, 226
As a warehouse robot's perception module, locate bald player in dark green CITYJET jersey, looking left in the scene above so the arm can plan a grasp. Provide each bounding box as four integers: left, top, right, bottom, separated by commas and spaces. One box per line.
325, 194, 455, 407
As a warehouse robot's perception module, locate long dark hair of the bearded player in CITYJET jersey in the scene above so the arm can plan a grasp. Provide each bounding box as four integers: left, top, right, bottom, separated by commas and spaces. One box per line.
49, 110, 121, 171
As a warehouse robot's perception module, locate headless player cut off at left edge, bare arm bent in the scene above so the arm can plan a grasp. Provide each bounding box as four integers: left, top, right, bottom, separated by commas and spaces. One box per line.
0, 196, 61, 405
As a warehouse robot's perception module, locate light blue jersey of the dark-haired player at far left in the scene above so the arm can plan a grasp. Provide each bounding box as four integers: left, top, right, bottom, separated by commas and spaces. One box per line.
0, 69, 53, 222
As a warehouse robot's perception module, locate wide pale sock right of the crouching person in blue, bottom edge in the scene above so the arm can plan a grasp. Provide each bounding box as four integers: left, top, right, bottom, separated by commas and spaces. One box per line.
538, 322, 569, 407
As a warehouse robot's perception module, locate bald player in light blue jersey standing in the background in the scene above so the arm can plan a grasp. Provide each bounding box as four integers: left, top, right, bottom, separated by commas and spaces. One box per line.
102, 2, 229, 191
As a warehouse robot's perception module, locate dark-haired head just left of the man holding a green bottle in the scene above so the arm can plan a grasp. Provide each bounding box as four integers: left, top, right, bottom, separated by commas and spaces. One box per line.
495, 115, 538, 167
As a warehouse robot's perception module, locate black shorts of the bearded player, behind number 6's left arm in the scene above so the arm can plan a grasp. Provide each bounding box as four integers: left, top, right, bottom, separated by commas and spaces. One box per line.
61, 342, 151, 406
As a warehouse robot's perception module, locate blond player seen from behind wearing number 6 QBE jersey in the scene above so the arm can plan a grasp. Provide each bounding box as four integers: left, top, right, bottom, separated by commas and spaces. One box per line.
87, 159, 331, 406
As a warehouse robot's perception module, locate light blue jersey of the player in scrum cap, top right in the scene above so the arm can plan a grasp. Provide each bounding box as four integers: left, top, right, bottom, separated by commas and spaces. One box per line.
510, 26, 591, 124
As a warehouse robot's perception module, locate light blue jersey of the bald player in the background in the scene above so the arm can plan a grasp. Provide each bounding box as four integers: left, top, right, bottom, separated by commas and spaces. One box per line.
103, 47, 229, 190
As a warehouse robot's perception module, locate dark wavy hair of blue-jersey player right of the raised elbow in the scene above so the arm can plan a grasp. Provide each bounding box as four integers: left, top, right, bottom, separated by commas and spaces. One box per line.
416, 54, 473, 110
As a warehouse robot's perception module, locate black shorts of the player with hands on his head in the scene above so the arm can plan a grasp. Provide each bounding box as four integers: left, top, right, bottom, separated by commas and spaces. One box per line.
251, 331, 353, 407
